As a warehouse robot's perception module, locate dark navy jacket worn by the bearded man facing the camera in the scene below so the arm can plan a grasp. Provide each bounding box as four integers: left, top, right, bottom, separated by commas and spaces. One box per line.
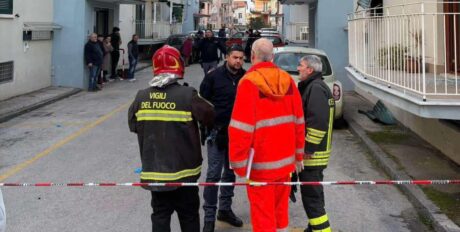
200, 62, 246, 127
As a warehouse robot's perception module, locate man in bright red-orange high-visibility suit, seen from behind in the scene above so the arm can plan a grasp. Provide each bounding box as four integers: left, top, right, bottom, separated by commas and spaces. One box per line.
229, 38, 305, 232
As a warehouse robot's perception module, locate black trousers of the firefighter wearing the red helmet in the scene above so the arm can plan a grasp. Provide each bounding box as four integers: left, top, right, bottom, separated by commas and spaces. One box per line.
152, 187, 200, 232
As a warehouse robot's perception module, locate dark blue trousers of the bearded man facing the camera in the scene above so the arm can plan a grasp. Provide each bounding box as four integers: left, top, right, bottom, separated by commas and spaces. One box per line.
203, 143, 235, 222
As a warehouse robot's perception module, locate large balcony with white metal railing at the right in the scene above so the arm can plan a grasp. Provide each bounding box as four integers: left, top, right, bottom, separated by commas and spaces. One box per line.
346, 2, 460, 120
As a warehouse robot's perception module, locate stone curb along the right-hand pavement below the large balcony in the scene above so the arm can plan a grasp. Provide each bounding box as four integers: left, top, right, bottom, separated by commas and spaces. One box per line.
345, 115, 460, 232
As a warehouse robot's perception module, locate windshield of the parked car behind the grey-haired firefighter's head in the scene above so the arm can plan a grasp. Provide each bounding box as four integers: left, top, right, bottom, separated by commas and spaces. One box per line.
273, 52, 332, 76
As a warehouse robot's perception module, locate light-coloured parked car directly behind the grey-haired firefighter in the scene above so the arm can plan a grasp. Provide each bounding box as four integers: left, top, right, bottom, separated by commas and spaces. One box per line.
273, 46, 344, 121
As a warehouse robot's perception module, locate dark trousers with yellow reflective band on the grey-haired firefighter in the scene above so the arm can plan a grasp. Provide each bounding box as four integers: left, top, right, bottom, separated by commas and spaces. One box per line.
299, 168, 329, 231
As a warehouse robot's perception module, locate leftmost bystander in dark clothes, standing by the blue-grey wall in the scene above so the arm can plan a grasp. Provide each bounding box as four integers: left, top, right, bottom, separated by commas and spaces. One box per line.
85, 33, 104, 91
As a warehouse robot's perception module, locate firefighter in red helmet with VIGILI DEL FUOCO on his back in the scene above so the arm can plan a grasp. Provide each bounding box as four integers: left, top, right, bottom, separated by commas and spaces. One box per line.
128, 45, 214, 232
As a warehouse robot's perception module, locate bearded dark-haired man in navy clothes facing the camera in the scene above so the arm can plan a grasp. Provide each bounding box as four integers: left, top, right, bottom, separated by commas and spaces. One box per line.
200, 45, 246, 232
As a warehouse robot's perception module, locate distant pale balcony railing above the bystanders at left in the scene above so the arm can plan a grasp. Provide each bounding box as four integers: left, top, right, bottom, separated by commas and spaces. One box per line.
134, 20, 182, 40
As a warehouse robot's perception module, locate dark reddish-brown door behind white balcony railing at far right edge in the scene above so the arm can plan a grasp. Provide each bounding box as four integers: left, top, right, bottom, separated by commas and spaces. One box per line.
444, 0, 460, 73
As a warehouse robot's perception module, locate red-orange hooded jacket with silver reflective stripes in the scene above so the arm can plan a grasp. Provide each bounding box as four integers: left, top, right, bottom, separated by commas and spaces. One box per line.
229, 62, 305, 181
